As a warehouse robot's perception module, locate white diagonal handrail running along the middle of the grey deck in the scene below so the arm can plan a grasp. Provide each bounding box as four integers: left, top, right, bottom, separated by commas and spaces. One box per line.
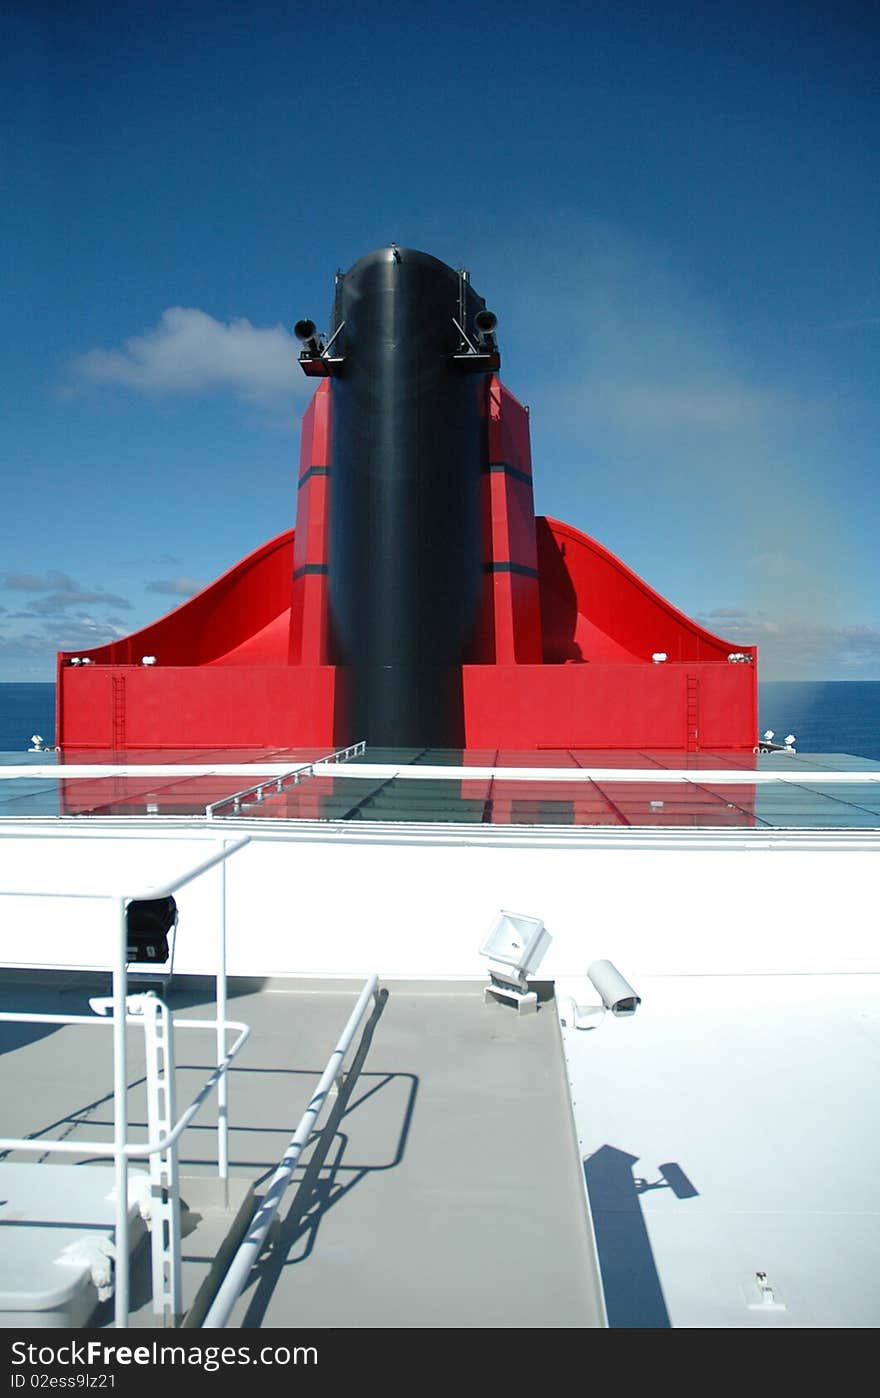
201, 974, 379, 1329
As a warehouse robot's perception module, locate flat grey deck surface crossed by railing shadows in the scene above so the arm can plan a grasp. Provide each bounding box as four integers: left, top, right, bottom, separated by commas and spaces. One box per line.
0, 976, 602, 1328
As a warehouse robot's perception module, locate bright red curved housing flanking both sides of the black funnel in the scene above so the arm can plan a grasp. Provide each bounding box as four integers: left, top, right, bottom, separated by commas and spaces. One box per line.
56, 377, 757, 754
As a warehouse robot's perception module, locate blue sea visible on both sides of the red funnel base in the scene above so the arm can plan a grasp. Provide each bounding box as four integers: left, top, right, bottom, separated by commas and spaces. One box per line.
0, 679, 880, 762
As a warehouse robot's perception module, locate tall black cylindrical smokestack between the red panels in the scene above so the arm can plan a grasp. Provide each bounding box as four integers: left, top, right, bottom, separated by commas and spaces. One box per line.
329, 245, 494, 748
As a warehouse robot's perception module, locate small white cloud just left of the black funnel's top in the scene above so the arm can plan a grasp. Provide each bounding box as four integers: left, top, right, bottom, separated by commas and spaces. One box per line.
70, 306, 308, 410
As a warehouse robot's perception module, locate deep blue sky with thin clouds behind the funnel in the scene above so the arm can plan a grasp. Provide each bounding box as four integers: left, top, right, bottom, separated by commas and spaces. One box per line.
0, 0, 880, 679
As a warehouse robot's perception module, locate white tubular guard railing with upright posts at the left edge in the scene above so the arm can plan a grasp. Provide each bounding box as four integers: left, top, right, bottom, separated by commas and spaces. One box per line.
0, 836, 250, 1328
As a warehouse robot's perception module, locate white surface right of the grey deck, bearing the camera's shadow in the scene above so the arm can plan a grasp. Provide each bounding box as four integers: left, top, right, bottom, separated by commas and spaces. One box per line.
557, 966, 880, 1328
